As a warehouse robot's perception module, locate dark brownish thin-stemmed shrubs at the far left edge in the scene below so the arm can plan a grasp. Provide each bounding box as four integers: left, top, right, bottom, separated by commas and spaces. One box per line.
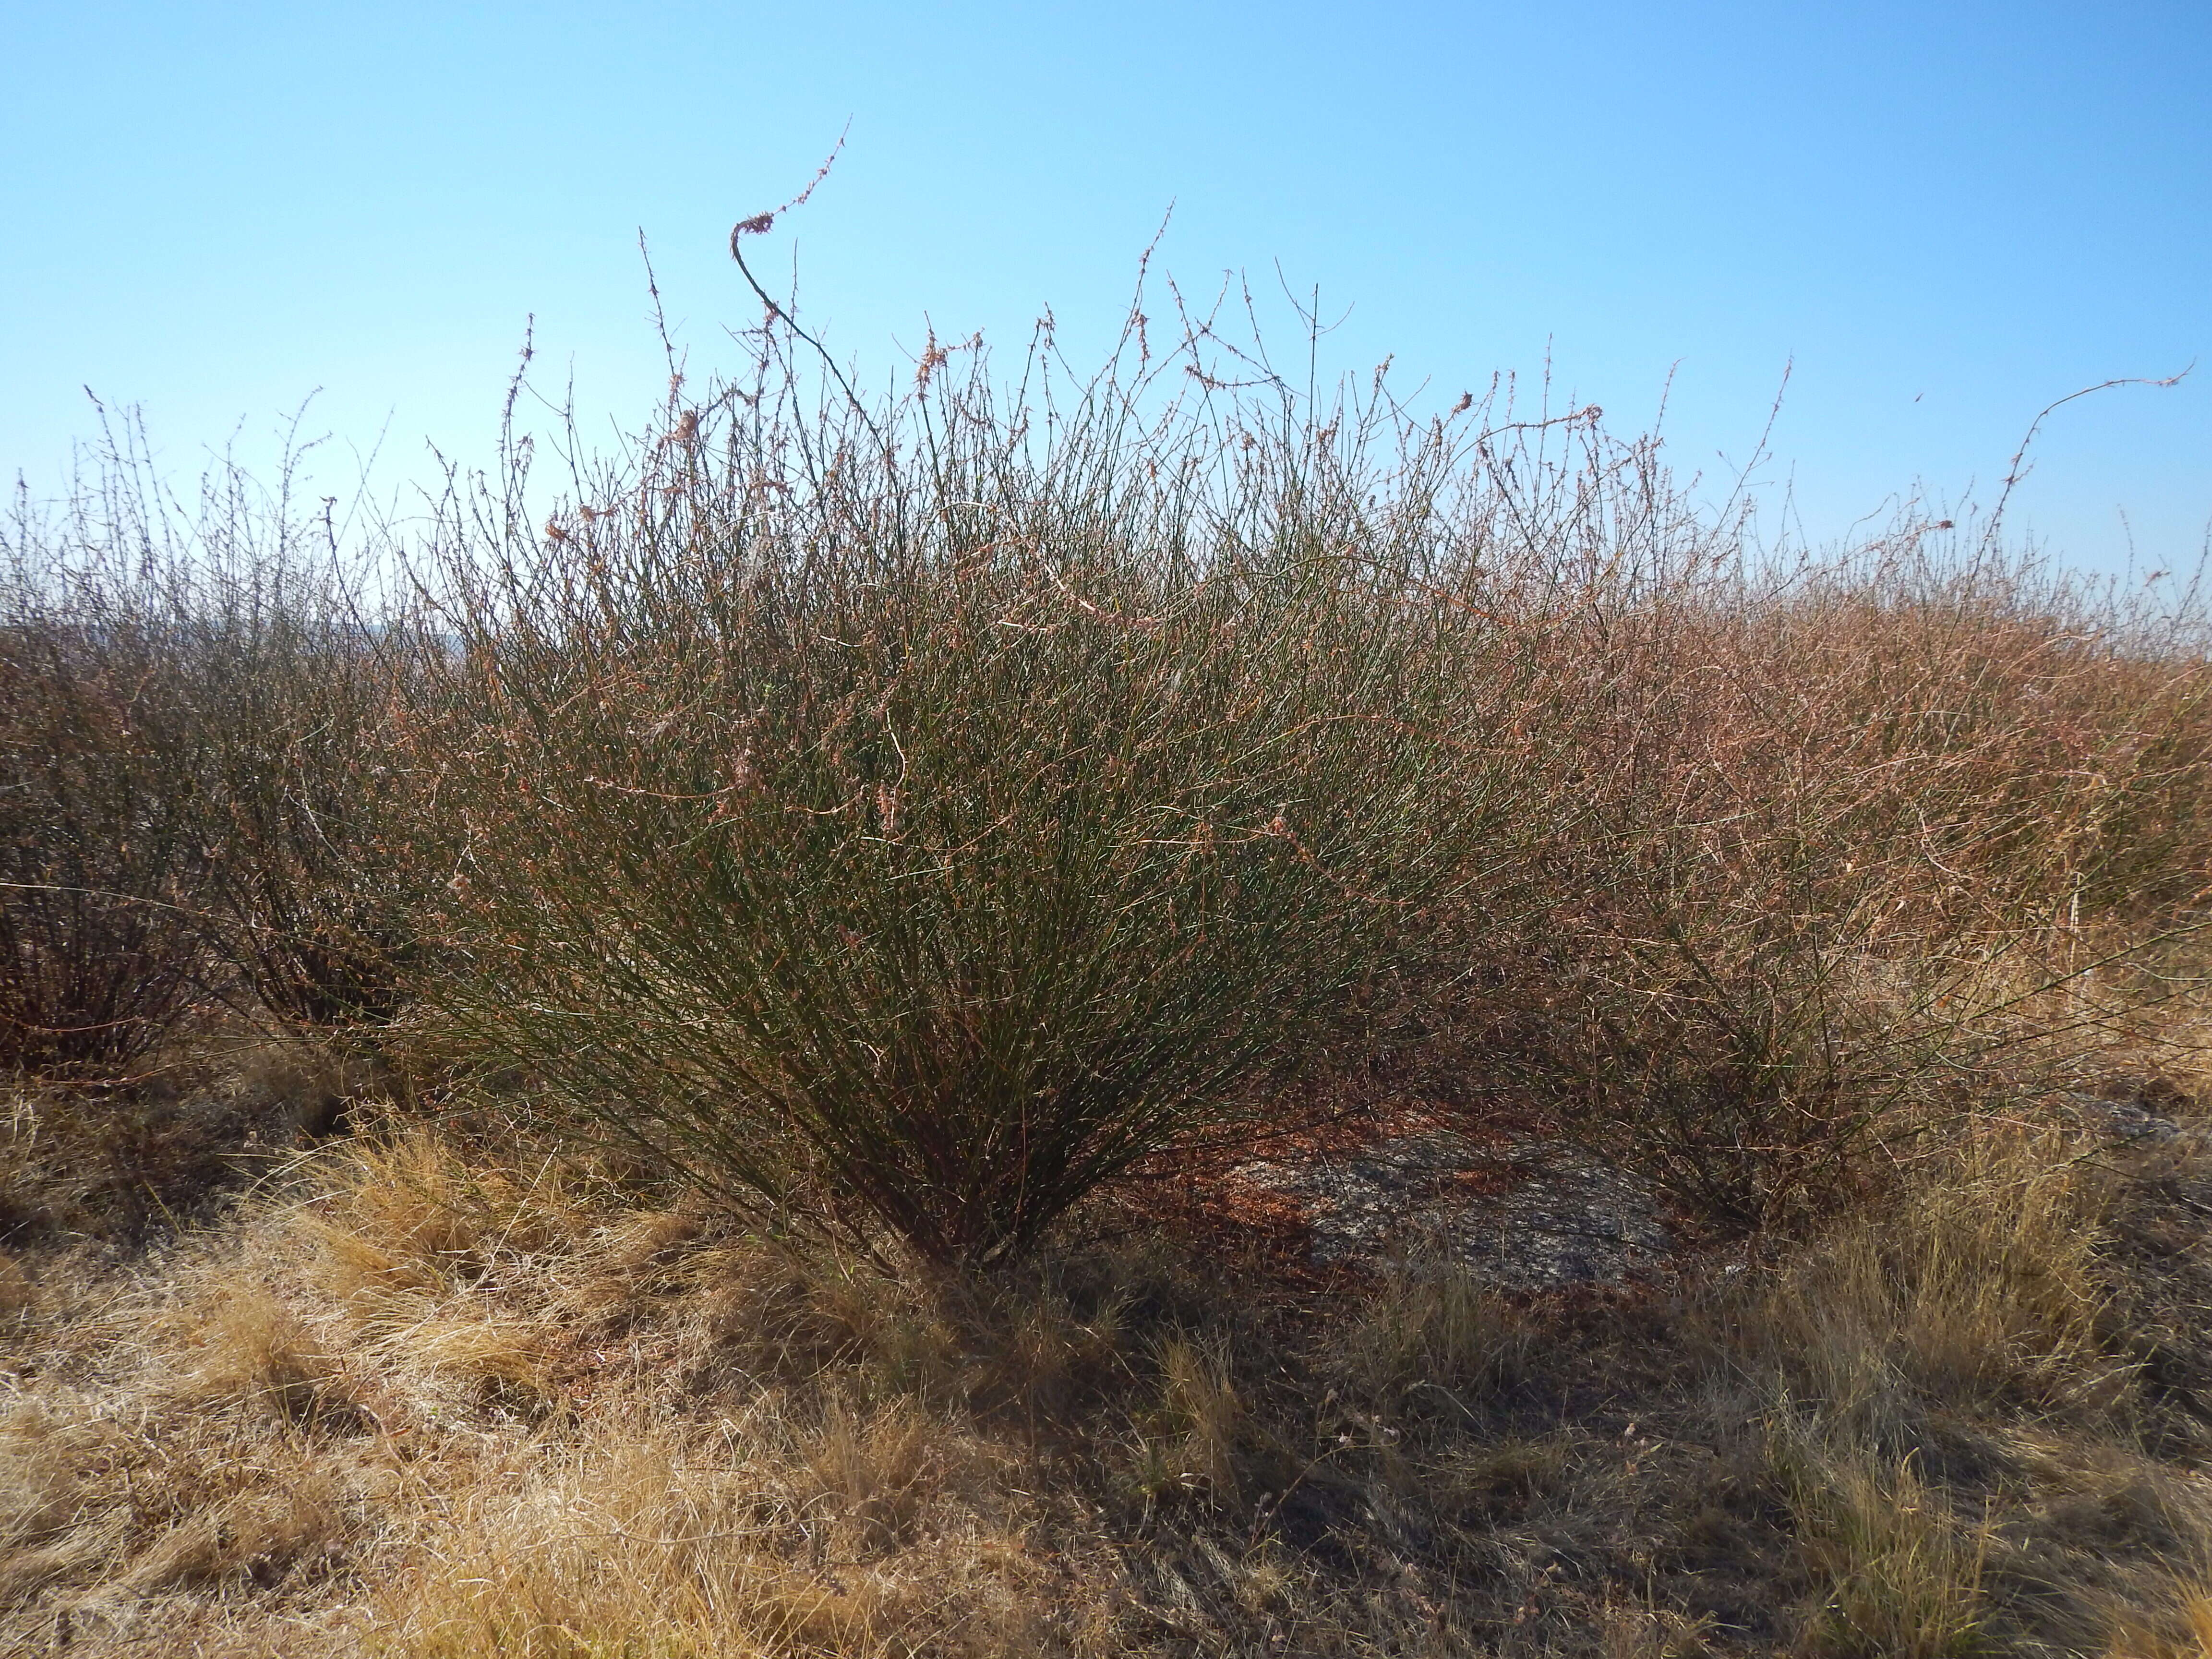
0, 422, 421, 1073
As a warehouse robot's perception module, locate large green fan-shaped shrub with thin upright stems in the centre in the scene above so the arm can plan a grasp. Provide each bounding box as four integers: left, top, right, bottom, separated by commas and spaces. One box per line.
420, 345, 1509, 1263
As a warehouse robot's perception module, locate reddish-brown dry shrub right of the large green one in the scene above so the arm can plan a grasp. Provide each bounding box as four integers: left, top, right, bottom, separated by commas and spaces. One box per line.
1491, 559, 2212, 1230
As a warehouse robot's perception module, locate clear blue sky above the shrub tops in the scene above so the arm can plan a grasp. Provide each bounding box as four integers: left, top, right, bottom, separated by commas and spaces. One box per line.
0, 0, 2212, 568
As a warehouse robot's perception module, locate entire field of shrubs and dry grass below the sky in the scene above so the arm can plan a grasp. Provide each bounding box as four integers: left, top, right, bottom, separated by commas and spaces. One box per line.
0, 319, 2212, 1659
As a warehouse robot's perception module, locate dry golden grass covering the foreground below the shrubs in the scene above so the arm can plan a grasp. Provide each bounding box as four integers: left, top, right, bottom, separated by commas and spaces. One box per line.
0, 1066, 2212, 1659
